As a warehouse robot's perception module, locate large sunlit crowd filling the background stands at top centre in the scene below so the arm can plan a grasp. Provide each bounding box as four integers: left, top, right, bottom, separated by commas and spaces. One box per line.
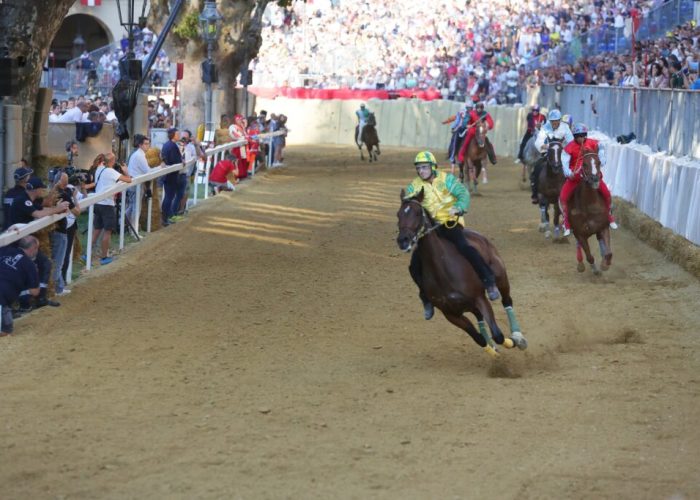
253, 0, 661, 102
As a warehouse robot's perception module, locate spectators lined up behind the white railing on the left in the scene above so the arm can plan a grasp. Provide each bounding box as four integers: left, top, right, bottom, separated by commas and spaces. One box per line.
0, 105, 287, 336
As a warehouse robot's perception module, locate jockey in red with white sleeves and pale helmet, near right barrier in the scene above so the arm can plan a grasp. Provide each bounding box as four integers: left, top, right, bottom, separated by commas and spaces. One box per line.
559, 123, 617, 236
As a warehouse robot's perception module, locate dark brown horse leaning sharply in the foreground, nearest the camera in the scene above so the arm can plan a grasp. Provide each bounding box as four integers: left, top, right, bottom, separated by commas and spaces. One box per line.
396, 190, 527, 356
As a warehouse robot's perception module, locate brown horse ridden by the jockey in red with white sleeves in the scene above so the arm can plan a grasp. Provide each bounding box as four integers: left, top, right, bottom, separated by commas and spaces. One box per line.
568, 149, 612, 275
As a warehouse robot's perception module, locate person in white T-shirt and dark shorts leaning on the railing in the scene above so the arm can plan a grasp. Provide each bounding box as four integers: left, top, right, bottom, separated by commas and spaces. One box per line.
91, 151, 131, 265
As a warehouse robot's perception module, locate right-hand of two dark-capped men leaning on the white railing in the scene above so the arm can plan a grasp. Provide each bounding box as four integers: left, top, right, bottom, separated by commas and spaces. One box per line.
10, 177, 68, 312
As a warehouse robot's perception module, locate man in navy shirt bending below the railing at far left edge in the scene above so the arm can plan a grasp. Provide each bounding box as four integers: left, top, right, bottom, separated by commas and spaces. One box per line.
0, 236, 39, 337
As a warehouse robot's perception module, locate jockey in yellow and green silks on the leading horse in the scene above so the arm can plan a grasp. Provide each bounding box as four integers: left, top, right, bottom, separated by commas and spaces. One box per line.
405, 151, 500, 319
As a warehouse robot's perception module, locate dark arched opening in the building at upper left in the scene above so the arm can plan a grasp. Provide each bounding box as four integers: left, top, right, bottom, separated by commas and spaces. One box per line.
49, 14, 114, 68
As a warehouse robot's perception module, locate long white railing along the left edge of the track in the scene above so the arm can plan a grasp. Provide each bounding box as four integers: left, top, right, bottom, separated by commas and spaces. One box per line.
0, 131, 286, 274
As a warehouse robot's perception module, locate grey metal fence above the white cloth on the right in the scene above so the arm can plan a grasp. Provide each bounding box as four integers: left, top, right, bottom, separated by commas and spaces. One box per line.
530, 85, 700, 159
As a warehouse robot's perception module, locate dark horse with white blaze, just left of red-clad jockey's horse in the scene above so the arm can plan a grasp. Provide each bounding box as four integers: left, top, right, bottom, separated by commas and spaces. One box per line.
537, 138, 565, 241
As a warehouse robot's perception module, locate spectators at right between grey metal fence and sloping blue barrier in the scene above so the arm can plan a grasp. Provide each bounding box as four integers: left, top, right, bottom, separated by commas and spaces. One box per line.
541, 22, 700, 90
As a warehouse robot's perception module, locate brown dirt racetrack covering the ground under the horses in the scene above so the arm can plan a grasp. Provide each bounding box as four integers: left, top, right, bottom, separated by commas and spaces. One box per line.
0, 147, 700, 499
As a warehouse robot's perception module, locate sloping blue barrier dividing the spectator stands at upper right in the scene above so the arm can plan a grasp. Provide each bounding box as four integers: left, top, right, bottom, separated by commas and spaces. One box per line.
525, 0, 694, 71
